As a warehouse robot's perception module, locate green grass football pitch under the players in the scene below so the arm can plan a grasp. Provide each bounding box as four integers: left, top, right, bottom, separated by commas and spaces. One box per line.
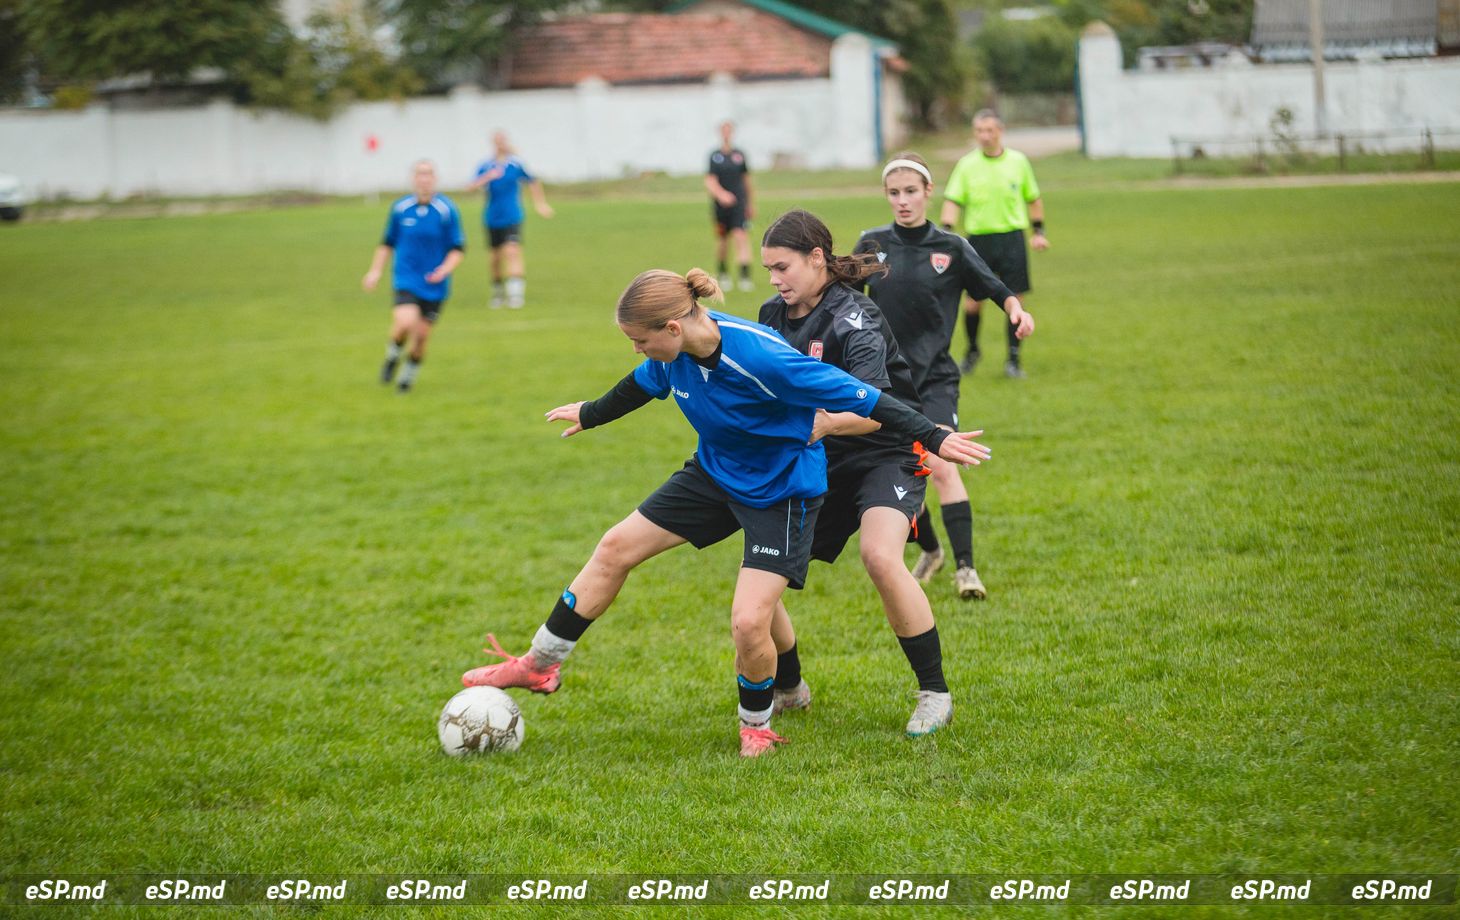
0, 176, 1460, 917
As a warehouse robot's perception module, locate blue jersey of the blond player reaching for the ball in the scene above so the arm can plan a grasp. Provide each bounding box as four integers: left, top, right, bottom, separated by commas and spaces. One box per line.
634, 310, 882, 508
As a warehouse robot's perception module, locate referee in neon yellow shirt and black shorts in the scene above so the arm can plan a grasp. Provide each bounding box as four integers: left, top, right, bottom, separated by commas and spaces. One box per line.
942, 108, 1050, 377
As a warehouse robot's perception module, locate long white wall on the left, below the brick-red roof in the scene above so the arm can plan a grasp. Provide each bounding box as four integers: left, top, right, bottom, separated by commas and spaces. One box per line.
0, 35, 901, 199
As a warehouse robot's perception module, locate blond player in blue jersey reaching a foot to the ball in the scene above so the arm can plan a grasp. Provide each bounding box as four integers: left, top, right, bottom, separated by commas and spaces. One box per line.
461, 269, 988, 756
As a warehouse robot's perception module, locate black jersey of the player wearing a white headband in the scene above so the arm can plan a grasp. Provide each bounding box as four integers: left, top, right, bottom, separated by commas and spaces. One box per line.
854, 222, 1015, 393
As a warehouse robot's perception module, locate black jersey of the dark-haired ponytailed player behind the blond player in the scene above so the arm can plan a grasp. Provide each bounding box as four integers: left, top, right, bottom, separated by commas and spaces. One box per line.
761, 283, 921, 469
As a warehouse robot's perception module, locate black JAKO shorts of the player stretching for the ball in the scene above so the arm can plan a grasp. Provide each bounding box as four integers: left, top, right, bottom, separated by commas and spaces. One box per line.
638, 457, 822, 590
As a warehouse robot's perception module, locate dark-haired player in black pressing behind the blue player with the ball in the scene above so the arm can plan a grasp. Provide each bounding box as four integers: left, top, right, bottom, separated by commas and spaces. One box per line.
761, 210, 980, 737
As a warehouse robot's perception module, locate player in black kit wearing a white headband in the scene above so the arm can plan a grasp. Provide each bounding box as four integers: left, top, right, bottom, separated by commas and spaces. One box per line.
854, 152, 1034, 600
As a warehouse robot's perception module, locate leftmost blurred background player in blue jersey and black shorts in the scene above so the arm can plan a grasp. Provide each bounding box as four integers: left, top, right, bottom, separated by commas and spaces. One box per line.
361, 159, 466, 393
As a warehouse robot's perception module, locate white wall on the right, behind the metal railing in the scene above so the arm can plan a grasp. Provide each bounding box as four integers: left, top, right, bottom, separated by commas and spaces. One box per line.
1079, 23, 1460, 156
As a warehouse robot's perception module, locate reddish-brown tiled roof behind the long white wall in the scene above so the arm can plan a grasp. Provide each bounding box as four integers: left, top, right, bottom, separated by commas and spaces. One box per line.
507, 7, 831, 89
